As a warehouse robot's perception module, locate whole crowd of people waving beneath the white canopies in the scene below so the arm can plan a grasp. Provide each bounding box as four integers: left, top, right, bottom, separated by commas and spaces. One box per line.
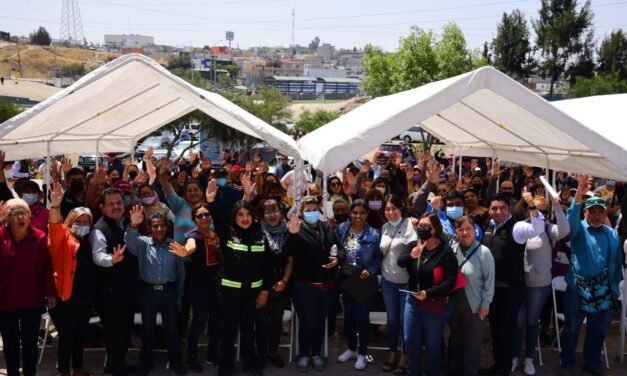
0, 144, 627, 376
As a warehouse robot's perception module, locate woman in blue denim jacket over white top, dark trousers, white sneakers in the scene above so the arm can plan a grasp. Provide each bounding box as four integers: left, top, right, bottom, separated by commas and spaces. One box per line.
337, 199, 382, 370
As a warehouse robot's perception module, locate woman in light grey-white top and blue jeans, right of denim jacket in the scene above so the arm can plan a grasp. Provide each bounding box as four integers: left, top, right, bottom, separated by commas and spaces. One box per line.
379, 195, 418, 375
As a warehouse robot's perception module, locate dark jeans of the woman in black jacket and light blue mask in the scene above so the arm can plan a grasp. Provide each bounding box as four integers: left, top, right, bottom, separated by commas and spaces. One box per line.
293, 282, 331, 356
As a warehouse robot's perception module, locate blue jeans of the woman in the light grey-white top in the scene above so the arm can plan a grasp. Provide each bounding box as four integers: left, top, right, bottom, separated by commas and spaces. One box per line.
381, 277, 407, 352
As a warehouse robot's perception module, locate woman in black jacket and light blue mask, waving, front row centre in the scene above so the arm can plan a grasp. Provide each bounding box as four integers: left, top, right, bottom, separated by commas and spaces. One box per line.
286, 196, 344, 372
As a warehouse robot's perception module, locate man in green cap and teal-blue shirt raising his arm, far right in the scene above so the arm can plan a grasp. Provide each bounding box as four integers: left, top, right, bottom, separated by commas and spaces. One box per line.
560, 175, 623, 375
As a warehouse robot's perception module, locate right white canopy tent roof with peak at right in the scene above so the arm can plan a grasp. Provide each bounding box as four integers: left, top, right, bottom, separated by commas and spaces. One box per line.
298, 67, 627, 180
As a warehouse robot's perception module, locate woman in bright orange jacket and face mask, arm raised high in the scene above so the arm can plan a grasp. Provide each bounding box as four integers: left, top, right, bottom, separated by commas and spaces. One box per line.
48, 183, 95, 376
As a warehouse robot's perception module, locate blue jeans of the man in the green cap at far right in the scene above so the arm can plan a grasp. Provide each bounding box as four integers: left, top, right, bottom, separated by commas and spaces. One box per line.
560, 286, 612, 369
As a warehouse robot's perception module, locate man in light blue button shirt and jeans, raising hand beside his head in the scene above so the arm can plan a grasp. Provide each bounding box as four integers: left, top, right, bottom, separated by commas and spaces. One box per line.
125, 205, 187, 376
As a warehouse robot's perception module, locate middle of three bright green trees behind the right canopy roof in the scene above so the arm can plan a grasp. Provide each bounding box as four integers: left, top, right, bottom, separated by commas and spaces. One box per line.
392, 26, 441, 92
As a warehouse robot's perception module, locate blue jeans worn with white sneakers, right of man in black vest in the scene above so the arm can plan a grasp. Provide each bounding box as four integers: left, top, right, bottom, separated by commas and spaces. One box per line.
512, 285, 551, 358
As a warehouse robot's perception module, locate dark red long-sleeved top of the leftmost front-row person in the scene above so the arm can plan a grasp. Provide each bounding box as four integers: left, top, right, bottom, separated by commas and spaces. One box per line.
0, 226, 57, 310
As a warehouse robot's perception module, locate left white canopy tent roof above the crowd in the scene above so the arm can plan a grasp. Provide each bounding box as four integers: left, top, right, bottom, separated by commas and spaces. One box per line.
0, 54, 300, 159
